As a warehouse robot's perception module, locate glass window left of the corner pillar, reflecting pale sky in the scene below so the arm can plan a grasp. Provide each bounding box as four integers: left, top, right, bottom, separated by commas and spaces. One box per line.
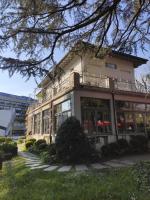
55, 99, 71, 131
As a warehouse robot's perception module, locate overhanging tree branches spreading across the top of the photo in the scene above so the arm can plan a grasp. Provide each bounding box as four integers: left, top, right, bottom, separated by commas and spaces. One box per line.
0, 0, 150, 77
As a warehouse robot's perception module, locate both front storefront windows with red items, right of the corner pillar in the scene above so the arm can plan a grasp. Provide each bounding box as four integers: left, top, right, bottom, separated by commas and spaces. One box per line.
81, 97, 150, 135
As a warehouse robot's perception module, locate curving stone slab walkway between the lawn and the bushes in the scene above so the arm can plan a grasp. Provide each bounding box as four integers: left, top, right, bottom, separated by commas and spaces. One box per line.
18, 152, 150, 172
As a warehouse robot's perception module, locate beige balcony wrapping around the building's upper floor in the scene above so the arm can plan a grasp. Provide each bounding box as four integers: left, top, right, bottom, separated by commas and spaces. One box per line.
29, 72, 150, 110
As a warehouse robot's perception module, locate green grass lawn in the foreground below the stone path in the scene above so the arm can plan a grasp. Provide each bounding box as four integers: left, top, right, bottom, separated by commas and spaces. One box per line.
0, 157, 150, 200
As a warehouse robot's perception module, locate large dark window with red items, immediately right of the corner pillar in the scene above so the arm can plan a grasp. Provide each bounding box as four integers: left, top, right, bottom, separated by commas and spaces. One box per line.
81, 98, 111, 134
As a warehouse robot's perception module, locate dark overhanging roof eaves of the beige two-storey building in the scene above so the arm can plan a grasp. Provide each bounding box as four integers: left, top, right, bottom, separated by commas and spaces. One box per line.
39, 41, 148, 87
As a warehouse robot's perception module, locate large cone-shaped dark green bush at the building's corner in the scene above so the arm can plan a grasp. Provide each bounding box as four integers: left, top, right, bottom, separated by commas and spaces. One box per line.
56, 117, 92, 163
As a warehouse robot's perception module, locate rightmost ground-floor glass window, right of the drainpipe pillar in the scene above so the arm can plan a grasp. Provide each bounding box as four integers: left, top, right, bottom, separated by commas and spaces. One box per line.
115, 101, 150, 134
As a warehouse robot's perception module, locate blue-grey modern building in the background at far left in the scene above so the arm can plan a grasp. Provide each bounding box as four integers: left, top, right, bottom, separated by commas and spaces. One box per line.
0, 92, 34, 136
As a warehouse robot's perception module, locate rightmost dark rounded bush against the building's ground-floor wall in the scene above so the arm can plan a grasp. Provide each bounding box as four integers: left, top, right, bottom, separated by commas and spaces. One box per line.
129, 135, 148, 153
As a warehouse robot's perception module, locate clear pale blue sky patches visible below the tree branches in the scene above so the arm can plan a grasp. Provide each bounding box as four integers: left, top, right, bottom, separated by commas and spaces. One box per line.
0, 48, 150, 97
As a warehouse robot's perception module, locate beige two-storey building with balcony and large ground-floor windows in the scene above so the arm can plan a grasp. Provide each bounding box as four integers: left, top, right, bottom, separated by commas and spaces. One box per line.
27, 44, 150, 148
